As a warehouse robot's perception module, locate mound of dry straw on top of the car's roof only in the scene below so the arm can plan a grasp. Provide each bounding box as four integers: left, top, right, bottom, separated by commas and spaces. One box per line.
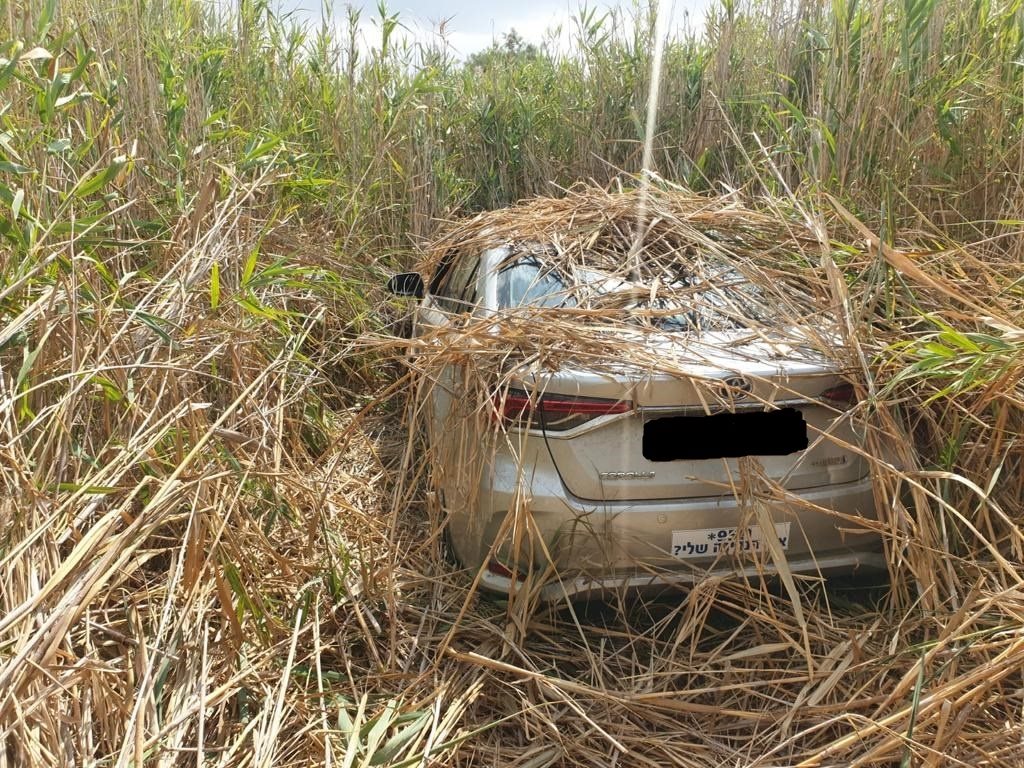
423, 186, 827, 309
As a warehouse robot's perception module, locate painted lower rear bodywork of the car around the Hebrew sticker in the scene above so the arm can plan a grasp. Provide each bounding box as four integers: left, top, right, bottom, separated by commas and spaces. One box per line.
450, 436, 881, 580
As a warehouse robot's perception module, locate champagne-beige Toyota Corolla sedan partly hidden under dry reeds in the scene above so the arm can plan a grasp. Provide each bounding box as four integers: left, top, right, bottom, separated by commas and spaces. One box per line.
389, 234, 885, 599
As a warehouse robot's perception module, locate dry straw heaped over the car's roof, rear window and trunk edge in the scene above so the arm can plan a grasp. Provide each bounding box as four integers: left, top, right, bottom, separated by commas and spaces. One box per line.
407, 186, 862, 382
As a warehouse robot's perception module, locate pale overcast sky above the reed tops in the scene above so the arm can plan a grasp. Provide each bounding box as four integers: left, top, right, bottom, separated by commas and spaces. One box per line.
276, 0, 717, 56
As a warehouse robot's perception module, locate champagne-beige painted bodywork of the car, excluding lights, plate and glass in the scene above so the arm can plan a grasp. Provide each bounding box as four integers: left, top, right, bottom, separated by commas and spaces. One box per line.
403, 243, 884, 597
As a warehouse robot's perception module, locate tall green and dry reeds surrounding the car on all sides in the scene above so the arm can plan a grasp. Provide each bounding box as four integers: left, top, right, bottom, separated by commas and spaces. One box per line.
0, 0, 1024, 768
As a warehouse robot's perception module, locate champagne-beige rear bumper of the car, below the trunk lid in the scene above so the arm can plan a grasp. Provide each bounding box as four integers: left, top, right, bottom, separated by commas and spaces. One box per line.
452, 442, 886, 600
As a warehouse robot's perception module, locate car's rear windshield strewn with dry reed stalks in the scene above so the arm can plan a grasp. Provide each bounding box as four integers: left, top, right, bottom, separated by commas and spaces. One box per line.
497, 255, 768, 331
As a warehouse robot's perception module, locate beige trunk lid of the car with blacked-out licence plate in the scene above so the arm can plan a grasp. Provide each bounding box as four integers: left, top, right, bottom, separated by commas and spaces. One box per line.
537, 331, 867, 501
